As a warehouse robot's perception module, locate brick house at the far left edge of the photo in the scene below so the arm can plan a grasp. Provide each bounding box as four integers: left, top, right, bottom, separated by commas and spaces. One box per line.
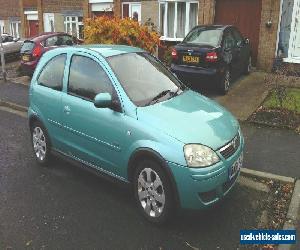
0, 0, 21, 38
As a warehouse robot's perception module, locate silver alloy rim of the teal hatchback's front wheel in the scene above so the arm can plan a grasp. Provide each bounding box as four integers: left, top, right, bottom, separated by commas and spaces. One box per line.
137, 168, 166, 218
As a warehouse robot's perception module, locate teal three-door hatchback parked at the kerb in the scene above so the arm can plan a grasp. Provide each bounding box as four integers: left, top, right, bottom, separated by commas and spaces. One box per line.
28, 45, 244, 223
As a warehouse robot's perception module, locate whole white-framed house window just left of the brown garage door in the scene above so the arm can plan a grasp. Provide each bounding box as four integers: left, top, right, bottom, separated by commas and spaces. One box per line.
159, 0, 198, 41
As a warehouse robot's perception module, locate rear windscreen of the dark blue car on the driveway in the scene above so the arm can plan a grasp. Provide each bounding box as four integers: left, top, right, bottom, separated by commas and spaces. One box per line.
183, 28, 222, 47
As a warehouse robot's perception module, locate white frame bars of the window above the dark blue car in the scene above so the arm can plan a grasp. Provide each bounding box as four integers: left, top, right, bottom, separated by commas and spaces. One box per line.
158, 0, 199, 42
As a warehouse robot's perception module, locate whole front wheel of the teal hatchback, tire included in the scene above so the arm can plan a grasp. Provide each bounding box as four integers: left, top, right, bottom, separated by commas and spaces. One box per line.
133, 159, 175, 224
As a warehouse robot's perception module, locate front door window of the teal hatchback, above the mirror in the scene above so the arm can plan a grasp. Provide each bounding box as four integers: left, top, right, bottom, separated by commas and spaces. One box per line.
68, 55, 112, 101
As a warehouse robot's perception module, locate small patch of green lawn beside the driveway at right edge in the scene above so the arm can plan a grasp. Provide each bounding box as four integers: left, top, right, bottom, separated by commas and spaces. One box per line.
263, 88, 300, 114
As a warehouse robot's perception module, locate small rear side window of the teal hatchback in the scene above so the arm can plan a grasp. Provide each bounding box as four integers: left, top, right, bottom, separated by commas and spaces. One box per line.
37, 54, 67, 90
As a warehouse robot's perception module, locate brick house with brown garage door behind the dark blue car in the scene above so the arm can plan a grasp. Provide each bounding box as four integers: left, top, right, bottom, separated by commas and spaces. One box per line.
114, 0, 300, 70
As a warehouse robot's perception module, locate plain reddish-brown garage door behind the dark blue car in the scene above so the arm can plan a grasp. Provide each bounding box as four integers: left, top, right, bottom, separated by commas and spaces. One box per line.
215, 0, 261, 64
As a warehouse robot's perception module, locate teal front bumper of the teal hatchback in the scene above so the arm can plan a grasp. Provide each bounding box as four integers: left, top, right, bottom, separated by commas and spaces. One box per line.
168, 137, 244, 209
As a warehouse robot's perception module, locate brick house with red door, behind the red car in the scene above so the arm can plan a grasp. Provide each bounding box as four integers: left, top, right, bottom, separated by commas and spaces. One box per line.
20, 0, 113, 38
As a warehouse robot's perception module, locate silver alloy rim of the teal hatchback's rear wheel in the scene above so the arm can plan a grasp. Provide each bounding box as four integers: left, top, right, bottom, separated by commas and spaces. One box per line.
32, 127, 47, 162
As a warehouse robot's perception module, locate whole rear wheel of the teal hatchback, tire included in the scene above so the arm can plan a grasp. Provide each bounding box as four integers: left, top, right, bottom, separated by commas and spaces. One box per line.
30, 121, 51, 166
